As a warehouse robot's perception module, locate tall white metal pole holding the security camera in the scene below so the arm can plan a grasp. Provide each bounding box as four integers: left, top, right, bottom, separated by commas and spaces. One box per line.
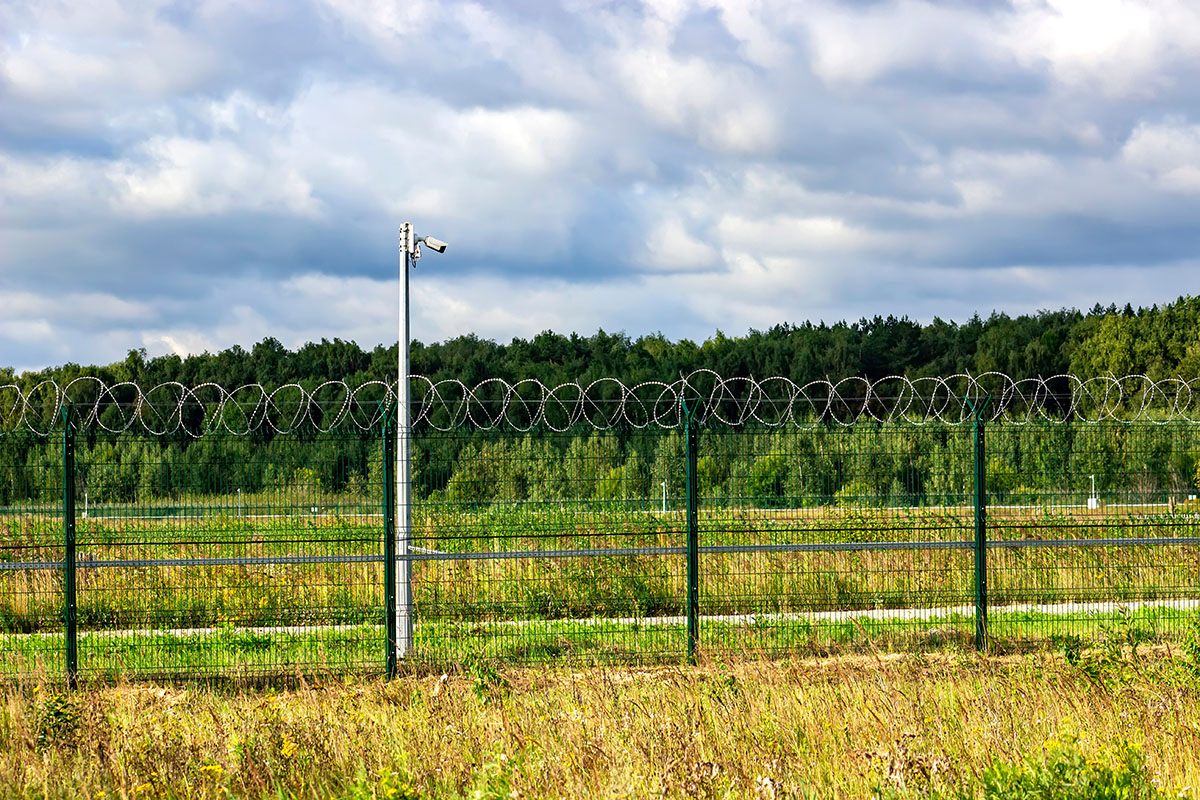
396, 222, 416, 660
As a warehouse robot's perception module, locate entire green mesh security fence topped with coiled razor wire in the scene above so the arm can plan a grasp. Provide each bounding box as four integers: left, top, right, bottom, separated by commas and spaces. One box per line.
0, 373, 1200, 682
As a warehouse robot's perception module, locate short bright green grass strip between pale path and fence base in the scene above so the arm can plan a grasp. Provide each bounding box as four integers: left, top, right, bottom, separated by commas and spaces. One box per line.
0, 608, 1200, 681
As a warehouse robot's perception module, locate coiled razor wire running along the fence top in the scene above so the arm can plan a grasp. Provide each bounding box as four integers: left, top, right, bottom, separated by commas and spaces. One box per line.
0, 369, 1200, 437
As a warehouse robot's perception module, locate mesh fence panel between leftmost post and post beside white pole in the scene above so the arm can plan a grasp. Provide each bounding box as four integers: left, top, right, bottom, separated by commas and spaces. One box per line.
70, 424, 385, 676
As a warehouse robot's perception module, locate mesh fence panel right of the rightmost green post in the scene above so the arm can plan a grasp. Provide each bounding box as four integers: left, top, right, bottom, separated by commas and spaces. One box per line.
988, 421, 1200, 643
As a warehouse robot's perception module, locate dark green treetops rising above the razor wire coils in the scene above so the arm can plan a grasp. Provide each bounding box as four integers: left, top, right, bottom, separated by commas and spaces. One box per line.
7, 295, 1200, 390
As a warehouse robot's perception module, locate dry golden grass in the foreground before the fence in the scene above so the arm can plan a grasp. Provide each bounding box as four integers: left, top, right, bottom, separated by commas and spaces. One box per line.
0, 651, 1200, 798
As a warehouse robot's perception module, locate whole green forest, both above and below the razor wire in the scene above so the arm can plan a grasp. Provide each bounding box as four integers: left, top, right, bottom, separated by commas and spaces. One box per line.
0, 296, 1200, 506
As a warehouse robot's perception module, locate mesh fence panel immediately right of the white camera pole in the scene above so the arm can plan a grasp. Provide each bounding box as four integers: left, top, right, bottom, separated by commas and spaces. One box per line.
412, 428, 686, 663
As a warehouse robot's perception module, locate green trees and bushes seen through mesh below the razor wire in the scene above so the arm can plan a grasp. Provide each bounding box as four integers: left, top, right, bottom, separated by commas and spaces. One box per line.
0, 420, 1200, 512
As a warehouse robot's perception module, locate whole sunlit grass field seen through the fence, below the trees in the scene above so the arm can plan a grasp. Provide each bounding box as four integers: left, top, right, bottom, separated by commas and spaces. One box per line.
0, 498, 1200, 674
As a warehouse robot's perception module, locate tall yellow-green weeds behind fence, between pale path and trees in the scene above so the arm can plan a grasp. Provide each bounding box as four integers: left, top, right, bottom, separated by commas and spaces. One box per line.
0, 507, 1200, 632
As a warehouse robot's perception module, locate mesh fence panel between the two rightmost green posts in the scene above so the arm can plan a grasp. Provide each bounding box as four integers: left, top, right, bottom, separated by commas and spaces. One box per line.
697, 423, 973, 652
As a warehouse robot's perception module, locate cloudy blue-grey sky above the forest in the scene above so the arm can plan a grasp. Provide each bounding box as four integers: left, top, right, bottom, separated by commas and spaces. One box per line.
0, 0, 1200, 371
